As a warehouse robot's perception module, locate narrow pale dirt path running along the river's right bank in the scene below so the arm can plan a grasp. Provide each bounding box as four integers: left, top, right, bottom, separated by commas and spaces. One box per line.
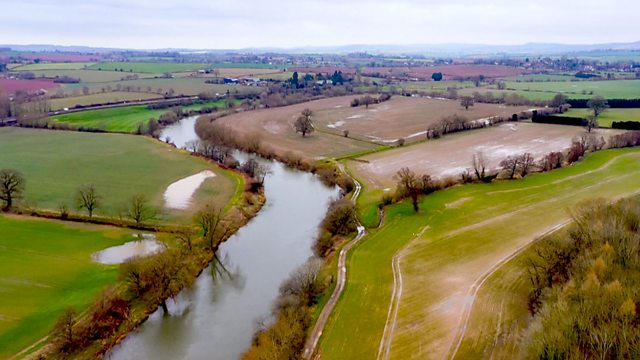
302, 179, 366, 359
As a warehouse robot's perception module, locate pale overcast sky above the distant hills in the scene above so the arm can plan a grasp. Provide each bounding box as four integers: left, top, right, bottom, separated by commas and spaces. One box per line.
0, 0, 640, 49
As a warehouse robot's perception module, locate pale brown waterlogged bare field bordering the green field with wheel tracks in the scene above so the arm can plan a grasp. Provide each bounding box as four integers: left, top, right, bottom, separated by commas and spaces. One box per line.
349, 123, 613, 187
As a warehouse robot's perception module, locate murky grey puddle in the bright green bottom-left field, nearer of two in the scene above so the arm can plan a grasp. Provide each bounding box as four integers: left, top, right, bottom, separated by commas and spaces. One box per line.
91, 234, 164, 265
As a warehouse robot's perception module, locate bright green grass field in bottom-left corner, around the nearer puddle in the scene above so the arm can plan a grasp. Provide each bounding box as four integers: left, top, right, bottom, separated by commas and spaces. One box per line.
0, 215, 140, 359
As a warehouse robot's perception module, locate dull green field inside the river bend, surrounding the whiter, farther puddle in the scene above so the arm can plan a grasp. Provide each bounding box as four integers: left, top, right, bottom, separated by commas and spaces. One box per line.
0, 128, 243, 221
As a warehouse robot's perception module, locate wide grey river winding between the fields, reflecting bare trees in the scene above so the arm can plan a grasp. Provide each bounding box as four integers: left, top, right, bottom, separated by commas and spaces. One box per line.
105, 117, 338, 360
